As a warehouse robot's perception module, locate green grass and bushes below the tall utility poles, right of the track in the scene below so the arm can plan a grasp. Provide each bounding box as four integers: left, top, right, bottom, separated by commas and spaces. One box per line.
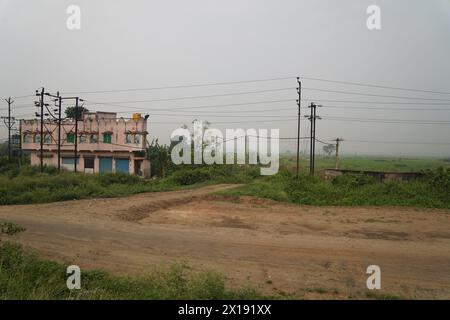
219, 168, 450, 208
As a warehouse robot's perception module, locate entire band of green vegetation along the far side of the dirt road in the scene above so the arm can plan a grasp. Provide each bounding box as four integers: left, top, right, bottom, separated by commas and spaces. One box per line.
0, 154, 450, 208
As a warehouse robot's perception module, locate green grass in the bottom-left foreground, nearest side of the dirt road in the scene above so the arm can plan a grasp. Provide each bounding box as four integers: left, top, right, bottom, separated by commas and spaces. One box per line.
0, 242, 268, 300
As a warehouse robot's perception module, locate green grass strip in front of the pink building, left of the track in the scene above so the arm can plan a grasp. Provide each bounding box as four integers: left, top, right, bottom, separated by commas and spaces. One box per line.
0, 165, 259, 205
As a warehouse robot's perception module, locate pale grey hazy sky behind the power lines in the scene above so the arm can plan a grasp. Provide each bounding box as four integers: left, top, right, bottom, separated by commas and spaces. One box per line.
0, 0, 450, 156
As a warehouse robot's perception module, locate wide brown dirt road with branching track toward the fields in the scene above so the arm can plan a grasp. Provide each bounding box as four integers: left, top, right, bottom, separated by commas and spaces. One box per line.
0, 185, 450, 299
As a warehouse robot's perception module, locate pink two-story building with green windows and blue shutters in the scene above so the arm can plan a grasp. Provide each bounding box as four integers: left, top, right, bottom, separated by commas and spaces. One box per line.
20, 112, 150, 178
